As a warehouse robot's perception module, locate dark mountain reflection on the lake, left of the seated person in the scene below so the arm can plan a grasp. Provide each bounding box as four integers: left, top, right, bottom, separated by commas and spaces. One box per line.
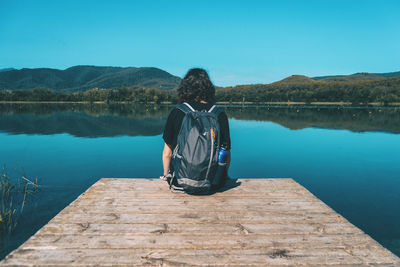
0, 104, 170, 137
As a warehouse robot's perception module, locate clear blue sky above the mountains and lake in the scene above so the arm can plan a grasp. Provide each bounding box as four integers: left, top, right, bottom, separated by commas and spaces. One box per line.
0, 0, 400, 86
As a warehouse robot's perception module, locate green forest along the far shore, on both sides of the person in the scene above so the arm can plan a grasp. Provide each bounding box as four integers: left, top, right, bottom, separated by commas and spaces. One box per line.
0, 74, 400, 105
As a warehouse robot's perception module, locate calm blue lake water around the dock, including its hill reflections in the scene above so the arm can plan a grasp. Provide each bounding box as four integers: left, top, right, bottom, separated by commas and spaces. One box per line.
0, 104, 400, 258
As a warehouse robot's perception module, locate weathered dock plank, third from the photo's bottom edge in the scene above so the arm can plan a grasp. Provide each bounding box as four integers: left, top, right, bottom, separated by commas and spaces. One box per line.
37, 222, 363, 235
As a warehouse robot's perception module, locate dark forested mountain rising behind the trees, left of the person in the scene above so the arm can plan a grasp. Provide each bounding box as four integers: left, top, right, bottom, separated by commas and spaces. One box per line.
0, 66, 180, 92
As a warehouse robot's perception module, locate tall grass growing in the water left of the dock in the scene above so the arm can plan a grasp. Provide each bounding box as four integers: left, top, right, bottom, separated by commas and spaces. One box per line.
0, 167, 40, 243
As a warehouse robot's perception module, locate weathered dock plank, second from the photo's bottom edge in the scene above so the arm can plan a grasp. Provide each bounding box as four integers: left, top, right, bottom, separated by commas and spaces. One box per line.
25, 232, 376, 249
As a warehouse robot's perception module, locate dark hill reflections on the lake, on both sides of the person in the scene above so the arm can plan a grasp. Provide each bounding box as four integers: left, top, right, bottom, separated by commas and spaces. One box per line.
0, 104, 400, 137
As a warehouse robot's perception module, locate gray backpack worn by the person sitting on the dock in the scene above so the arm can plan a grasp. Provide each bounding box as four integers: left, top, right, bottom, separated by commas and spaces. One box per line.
170, 103, 221, 194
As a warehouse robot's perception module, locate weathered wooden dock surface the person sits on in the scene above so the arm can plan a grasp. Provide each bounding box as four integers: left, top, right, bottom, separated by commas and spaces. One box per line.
0, 178, 400, 266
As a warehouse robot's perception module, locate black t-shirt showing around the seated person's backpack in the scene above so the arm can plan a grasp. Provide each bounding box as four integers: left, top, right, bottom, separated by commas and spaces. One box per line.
163, 102, 231, 150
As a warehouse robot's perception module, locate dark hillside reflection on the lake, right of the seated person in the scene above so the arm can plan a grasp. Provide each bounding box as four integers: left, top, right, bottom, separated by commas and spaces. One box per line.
223, 106, 400, 133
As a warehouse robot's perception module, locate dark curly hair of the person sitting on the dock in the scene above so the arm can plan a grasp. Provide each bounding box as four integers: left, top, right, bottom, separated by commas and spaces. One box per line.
177, 68, 215, 102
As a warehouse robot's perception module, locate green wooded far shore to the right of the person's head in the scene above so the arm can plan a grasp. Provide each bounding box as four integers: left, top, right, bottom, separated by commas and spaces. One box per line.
217, 77, 400, 104
